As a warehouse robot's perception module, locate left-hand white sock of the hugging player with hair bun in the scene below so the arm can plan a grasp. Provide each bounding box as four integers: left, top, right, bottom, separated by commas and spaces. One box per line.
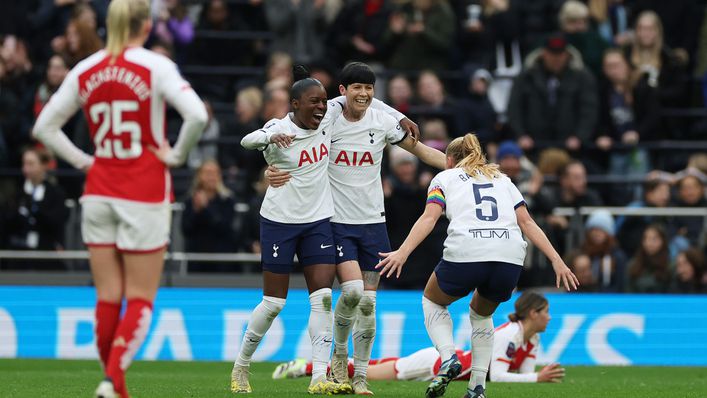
235, 296, 285, 366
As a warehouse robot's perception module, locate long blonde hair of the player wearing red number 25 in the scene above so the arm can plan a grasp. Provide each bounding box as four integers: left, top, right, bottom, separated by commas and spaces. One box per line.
106, 0, 150, 57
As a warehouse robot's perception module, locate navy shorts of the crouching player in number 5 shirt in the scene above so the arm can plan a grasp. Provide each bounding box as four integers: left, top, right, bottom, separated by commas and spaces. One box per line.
435, 260, 523, 303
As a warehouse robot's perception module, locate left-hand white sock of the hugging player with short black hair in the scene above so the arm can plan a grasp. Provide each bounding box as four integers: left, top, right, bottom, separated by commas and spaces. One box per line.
334, 279, 363, 355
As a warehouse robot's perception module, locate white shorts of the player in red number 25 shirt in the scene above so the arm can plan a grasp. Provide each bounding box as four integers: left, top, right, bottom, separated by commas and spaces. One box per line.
81, 200, 172, 253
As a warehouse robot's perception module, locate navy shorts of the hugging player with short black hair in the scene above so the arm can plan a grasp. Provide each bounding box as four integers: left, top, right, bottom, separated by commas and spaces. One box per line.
331, 222, 390, 271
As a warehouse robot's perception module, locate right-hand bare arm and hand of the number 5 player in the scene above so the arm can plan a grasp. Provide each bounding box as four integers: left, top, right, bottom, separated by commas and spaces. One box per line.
516, 206, 579, 291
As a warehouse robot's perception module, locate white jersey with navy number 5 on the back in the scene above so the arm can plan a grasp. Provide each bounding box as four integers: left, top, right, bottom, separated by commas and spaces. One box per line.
427, 168, 527, 265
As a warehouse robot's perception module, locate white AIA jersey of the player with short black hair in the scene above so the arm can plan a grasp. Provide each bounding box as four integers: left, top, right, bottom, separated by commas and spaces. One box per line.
329, 107, 406, 224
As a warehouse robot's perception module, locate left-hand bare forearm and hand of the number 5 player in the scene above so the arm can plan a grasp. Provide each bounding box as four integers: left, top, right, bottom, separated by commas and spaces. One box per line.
376, 203, 443, 278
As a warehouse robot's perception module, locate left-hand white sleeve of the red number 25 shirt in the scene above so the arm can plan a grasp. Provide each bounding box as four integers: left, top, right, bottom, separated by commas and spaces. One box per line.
32, 72, 93, 169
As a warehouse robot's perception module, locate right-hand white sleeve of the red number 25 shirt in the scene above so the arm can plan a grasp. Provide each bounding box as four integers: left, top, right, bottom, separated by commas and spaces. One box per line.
158, 61, 209, 166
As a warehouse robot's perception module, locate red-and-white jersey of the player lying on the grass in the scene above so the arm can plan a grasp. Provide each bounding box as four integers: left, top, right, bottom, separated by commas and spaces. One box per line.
489, 322, 540, 383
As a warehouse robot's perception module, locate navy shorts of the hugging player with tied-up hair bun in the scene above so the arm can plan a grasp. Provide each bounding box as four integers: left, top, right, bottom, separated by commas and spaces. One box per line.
260, 217, 334, 274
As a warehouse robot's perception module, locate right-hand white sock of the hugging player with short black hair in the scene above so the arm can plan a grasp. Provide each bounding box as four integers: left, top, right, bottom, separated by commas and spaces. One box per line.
353, 290, 376, 378
